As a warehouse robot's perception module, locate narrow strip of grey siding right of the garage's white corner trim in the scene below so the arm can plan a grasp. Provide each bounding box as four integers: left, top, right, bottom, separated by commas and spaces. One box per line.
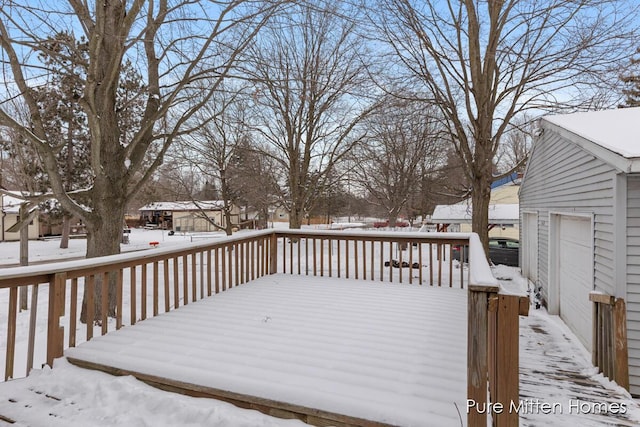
626, 175, 640, 395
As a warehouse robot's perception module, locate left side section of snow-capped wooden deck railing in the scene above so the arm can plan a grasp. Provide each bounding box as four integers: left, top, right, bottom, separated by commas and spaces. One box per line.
0, 232, 277, 380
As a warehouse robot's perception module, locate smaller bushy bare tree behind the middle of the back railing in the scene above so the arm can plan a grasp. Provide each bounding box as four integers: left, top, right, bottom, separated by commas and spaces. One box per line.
353, 96, 442, 227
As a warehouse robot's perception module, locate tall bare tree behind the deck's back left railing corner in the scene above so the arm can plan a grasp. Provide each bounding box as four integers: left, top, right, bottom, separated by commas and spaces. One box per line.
246, 0, 372, 228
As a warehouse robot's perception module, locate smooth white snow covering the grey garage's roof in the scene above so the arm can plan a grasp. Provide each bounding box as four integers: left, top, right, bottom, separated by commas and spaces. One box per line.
543, 107, 640, 159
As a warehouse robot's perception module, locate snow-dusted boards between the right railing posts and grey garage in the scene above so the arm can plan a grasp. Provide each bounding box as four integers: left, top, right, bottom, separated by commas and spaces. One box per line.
519, 308, 640, 427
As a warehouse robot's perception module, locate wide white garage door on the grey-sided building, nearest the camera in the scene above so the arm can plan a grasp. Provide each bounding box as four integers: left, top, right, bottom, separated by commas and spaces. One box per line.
557, 215, 593, 352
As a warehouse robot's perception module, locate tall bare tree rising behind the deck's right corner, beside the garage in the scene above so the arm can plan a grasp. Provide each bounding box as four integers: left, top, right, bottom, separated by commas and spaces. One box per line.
372, 0, 638, 251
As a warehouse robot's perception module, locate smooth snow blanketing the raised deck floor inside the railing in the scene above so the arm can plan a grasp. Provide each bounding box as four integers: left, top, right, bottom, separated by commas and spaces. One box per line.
65, 275, 467, 426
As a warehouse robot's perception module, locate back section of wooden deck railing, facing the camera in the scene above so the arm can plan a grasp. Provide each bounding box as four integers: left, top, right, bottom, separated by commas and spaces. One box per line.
276, 230, 469, 289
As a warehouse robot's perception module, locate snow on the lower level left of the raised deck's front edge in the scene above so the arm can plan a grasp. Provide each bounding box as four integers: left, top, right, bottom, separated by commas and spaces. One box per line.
0, 359, 306, 427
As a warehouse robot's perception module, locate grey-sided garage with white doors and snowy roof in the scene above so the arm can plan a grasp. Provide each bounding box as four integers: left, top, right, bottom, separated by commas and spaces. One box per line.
520, 108, 640, 395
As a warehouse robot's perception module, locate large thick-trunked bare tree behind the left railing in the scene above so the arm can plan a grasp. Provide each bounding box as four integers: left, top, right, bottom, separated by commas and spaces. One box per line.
0, 0, 280, 320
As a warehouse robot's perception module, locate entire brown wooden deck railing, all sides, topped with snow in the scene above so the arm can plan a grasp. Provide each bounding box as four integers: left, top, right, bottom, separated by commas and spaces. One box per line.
0, 230, 523, 426
